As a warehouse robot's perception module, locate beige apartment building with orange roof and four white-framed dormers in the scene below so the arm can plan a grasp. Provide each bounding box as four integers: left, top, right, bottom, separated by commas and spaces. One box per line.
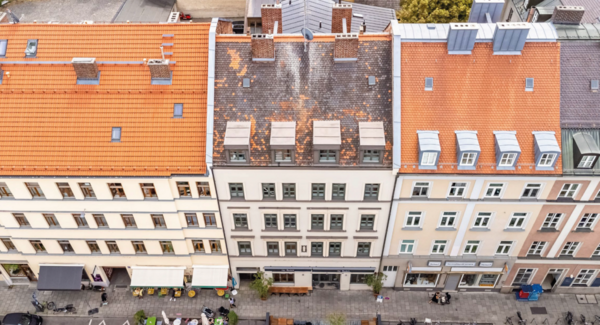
381, 20, 562, 291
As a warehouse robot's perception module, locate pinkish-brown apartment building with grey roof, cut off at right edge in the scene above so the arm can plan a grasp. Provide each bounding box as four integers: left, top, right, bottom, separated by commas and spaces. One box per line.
508, 41, 600, 293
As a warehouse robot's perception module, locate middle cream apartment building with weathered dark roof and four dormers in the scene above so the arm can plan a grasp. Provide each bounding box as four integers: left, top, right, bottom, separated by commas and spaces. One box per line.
213, 10, 394, 290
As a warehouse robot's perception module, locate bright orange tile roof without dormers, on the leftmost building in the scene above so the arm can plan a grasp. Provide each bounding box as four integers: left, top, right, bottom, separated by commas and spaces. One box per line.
0, 24, 210, 176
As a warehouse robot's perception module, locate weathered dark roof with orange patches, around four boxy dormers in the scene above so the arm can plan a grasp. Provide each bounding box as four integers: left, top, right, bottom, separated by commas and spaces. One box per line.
213, 37, 393, 168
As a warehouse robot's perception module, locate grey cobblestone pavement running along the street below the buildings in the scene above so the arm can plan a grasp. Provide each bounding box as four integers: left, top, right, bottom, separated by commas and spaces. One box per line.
0, 286, 600, 325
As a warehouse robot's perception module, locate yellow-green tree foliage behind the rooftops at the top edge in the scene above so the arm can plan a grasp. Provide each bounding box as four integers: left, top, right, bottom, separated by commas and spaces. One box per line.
396, 0, 473, 24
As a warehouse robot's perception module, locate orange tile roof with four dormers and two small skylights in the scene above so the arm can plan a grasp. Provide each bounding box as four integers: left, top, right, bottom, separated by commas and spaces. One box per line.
400, 42, 562, 174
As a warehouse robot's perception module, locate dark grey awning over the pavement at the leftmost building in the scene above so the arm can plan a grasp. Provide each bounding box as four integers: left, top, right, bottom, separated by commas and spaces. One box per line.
38, 264, 83, 291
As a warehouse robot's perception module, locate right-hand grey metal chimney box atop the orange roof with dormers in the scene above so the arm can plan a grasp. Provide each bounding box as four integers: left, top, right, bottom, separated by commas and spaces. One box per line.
494, 23, 531, 55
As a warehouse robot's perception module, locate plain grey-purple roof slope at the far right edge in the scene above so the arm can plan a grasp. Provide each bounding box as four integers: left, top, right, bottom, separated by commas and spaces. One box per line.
560, 42, 600, 128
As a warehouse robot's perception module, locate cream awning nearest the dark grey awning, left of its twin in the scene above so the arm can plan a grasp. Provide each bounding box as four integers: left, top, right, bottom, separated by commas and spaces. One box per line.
131, 266, 185, 288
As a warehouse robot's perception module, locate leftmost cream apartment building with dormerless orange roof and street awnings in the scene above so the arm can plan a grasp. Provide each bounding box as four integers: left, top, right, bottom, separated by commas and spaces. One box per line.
0, 23, 228, 290
